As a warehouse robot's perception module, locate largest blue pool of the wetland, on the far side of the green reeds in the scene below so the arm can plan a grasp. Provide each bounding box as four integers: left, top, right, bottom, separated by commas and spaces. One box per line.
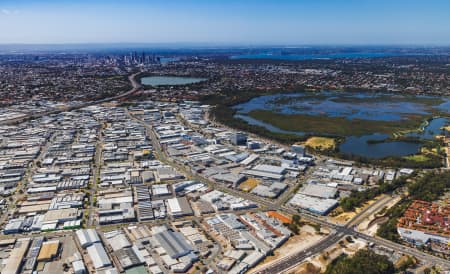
234, 91, 450, 121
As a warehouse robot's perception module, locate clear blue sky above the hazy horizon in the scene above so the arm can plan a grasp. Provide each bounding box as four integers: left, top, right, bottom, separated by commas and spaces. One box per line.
0, 0, 450, 45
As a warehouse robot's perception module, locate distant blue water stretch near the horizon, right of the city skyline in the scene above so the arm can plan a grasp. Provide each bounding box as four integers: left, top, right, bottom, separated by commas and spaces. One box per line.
229, 52, 403, 61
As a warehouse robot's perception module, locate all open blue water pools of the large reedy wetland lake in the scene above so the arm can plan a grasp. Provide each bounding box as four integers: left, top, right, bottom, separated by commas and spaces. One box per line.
234, 91, 450, 158
